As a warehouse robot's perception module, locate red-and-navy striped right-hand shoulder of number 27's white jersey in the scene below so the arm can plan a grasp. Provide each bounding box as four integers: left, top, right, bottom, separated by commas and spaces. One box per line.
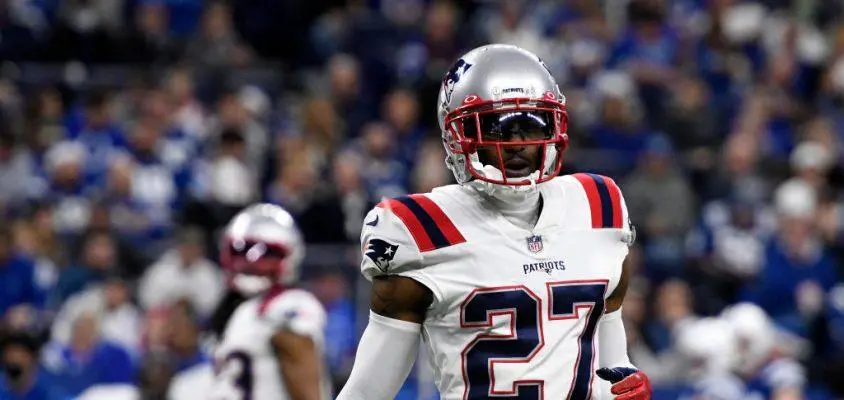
564, 173, 636, 245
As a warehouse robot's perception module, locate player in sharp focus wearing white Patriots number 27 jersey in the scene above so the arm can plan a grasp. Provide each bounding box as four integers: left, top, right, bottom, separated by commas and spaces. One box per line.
338, 44, 650, 400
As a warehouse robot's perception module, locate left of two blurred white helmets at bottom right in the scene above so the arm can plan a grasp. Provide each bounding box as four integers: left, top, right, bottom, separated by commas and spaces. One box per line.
676, 317, 737, 381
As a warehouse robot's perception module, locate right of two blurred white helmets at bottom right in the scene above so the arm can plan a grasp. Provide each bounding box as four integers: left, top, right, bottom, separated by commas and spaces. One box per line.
721, 303, 776, 375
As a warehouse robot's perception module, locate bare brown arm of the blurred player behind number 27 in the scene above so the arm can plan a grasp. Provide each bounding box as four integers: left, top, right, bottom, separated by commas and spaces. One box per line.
272, 330, 322, 400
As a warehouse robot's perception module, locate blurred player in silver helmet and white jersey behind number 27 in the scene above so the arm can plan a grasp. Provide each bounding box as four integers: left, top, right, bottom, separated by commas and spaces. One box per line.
210, 204, 330, 400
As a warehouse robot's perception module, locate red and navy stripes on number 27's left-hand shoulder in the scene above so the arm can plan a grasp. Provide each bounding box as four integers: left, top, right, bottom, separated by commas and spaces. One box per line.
378, 194, 466, 252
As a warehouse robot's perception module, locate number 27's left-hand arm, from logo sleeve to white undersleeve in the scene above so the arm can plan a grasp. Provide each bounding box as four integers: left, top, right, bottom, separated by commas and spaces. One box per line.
337, 208, 434, 400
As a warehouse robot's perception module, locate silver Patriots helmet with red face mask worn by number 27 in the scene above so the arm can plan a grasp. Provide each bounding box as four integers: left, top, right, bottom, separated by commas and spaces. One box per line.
437, 44, 568, 186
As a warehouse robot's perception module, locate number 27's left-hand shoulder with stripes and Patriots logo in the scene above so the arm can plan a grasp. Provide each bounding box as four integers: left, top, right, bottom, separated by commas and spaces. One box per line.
360, 194, 466, 279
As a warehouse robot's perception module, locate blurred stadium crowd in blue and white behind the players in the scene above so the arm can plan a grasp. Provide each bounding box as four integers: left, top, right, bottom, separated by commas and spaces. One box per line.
0, 0, 844, 399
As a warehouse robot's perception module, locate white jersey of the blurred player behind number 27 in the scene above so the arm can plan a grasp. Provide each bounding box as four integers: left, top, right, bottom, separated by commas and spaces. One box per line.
210, 289, 330, 400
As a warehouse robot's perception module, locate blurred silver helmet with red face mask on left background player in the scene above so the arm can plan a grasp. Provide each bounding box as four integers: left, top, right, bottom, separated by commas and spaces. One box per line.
220, 204, 305, 295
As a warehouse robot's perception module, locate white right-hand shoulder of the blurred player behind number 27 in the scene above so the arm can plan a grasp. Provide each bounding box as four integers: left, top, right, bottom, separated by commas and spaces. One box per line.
260, 289, 326, 343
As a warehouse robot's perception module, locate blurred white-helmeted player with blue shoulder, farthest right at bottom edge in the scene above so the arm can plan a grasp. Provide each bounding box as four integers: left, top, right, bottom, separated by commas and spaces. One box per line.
721, 303, 807, 400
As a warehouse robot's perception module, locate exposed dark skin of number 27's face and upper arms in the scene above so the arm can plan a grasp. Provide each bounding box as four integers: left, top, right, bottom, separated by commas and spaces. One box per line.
370, 122, 630, 324
